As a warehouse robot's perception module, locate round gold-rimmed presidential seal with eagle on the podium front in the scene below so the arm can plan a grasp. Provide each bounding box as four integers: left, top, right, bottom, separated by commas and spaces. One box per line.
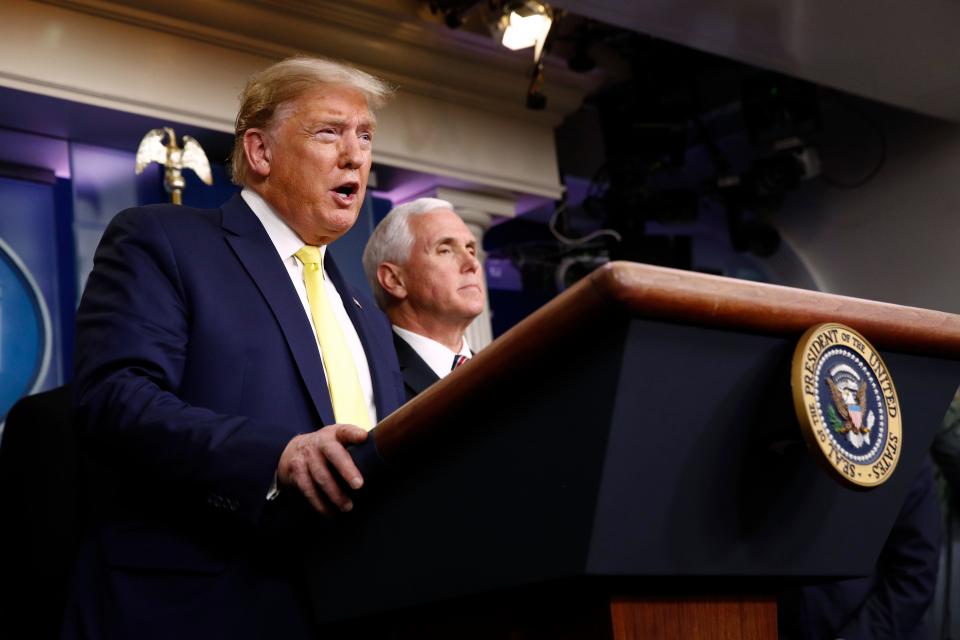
791, 322, 903, 488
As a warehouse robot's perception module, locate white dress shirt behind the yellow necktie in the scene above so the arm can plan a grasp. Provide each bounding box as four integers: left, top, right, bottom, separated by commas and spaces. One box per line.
240, 188, 377, 427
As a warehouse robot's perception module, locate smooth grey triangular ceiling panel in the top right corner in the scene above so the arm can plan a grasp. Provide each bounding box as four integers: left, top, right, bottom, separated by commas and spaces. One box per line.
552, 0, 960, 122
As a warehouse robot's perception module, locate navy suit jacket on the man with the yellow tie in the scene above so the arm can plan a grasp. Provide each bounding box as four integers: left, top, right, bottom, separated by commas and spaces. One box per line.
65, 195, 403, 638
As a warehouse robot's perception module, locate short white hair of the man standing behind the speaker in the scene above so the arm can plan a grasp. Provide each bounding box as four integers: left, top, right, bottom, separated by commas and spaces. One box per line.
363, 198, 453, 311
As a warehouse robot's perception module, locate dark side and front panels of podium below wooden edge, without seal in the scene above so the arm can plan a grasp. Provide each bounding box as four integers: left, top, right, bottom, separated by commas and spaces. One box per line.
309, 313, 960, 621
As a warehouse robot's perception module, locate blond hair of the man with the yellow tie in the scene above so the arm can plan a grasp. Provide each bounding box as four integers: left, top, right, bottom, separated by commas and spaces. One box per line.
230, 56, 393, 185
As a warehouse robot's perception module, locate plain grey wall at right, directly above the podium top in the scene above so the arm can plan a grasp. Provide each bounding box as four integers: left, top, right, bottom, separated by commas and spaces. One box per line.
772, 101, 960, 313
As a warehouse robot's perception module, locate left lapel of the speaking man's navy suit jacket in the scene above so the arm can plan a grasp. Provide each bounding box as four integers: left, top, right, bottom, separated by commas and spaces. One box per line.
221, 194, 335, 424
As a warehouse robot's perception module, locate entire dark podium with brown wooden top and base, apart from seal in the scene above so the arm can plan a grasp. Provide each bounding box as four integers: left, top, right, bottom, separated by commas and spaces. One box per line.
308, 263, 960, 639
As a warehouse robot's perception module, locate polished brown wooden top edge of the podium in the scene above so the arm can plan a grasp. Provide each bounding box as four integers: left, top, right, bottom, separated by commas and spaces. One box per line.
375, 262, 960, 459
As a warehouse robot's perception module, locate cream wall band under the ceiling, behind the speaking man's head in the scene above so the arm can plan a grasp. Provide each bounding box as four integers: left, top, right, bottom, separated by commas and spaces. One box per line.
0, 0, 563, 198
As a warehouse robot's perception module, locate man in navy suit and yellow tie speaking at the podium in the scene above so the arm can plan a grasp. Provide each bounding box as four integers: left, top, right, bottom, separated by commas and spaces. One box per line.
64, 58, 403, 639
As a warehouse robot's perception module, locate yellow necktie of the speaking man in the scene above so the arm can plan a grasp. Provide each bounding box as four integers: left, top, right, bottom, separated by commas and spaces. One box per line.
294, 245, 373, 431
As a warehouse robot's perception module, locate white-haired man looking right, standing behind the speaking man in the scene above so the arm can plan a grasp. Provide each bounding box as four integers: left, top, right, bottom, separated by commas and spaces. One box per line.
363, 198, 485, 400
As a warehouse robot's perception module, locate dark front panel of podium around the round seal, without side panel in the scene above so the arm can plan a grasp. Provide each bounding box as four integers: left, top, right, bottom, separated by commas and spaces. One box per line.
588, 320, 960, 577
